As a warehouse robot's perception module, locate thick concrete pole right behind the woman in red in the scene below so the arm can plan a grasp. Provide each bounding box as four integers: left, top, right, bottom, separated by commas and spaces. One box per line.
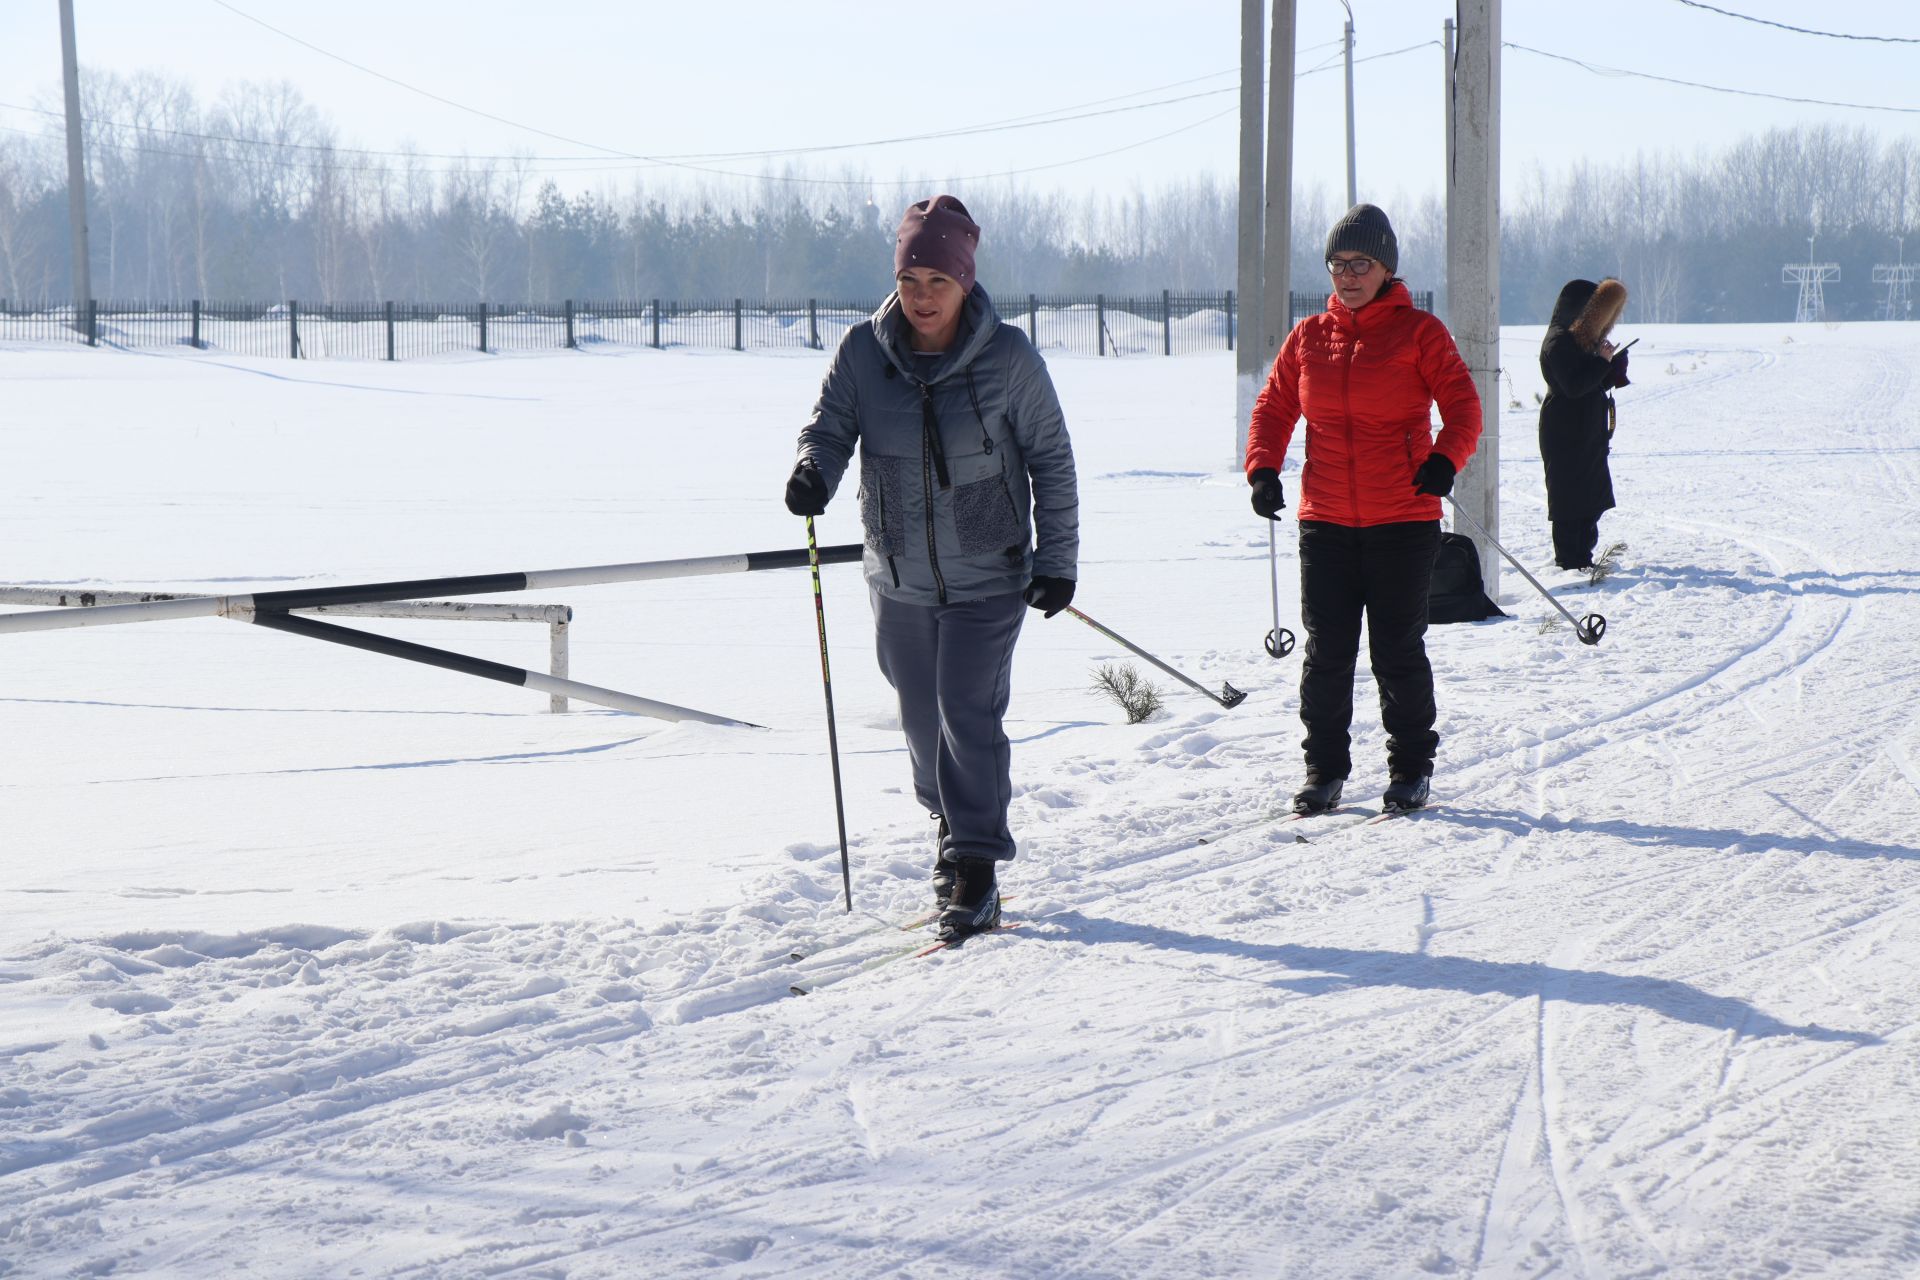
1446, 0, 1500, 601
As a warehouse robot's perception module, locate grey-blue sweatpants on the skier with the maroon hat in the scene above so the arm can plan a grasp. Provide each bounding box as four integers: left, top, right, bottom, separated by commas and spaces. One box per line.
868, 587, 1027, 862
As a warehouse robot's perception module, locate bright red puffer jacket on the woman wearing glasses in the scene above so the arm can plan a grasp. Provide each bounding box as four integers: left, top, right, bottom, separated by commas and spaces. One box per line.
1246, 280, 1480, 526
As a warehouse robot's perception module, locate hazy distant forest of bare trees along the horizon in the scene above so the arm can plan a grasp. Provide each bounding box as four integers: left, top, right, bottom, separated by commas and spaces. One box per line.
0, 73, 1920, 324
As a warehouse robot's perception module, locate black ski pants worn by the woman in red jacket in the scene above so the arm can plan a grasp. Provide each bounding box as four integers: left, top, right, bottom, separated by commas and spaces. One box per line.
1300, 520, 1440, 777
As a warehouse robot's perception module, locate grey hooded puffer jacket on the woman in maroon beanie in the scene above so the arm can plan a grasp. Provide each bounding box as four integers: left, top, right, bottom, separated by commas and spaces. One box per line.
801, 284, 1079, 604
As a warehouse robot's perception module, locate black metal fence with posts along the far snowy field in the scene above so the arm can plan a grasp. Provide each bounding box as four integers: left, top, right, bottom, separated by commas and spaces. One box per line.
0, 290, 1432, 361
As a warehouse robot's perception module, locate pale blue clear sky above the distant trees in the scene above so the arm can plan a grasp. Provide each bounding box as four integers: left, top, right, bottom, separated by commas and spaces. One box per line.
0, 0, 1920, 205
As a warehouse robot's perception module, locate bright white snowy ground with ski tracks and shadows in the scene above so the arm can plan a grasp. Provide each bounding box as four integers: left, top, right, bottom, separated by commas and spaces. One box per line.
0, 324, 1920, 1280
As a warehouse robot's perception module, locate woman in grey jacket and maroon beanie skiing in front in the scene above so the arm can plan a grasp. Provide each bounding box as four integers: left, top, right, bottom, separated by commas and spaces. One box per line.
787, 196, 1079, 942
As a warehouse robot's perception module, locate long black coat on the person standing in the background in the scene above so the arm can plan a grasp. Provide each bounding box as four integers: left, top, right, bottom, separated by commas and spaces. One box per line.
1540, 280, 1613, 520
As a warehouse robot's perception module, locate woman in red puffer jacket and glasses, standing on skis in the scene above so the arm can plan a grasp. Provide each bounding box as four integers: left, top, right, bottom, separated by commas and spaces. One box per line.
1246, 205, 1480, 814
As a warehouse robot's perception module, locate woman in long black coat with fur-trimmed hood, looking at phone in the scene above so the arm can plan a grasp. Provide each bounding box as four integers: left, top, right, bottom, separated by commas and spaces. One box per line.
1540, 278, 1626, 568
